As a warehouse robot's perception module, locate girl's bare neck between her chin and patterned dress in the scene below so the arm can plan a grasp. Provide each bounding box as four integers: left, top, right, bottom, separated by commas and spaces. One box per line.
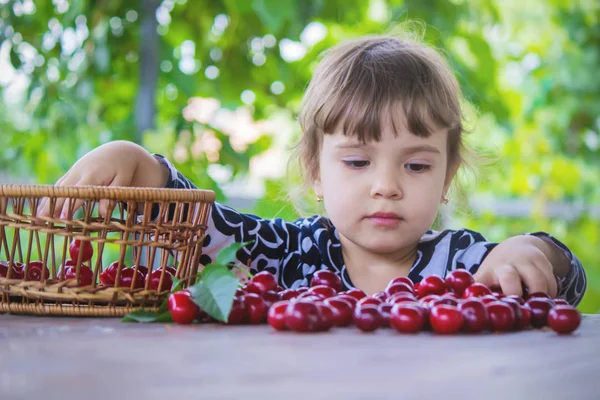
340, 235, 417, 294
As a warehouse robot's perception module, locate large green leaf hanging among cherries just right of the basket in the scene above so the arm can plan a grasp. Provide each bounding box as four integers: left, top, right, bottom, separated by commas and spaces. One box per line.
188, 264, 238, 322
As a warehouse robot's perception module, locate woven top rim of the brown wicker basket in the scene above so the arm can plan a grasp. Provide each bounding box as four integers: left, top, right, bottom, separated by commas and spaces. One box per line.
0, 183, 216, 203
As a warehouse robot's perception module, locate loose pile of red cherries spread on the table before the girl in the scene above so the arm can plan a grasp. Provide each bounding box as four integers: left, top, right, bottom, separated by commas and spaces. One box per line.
168, 269, 581, 334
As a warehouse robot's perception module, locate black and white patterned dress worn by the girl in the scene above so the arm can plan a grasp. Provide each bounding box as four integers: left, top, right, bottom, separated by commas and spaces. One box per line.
154, 154, 587, 305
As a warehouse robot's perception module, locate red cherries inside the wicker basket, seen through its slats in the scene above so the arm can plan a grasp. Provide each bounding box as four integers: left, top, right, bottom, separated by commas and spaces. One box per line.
0, 240, 177, 291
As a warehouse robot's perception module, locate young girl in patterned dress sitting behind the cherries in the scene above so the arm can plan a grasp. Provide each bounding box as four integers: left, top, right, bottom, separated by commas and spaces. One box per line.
41, 36, 586, 305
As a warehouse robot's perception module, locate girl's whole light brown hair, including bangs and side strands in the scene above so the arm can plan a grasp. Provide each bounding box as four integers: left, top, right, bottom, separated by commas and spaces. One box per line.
291, 29, 480, 219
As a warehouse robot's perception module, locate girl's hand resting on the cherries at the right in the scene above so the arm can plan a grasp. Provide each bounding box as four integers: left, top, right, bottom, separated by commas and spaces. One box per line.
473, 235, 564, 297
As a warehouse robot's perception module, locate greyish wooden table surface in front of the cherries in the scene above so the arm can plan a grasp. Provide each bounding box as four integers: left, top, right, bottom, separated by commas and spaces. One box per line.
0, 315, 600, 400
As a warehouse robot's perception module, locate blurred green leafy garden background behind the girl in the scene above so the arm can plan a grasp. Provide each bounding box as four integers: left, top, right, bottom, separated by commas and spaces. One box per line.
0, 0, 600, 313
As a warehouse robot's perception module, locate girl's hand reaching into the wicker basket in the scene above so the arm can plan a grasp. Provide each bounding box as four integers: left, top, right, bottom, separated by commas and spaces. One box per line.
38, 141, 168, 218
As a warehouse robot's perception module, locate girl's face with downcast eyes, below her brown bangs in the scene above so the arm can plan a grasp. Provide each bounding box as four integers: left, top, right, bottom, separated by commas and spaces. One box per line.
314, 118, 453, 255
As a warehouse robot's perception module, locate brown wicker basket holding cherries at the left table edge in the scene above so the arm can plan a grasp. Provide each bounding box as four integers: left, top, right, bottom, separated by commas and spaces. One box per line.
0, 185, 215, 317
